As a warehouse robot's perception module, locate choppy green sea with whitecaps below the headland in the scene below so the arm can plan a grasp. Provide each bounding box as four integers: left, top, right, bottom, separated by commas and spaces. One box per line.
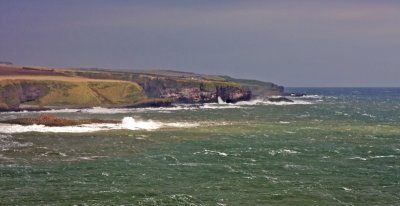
0, 88, 400, 206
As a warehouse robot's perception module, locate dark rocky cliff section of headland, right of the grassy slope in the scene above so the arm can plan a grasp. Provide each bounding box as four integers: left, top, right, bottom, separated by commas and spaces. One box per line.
72, 71, 252, 103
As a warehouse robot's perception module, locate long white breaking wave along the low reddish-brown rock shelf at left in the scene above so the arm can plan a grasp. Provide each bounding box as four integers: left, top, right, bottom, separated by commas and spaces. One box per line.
0, 117, 199, 134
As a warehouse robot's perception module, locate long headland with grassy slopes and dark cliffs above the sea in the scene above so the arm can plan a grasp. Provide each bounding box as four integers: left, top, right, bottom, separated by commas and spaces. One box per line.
0, 62, 284, 111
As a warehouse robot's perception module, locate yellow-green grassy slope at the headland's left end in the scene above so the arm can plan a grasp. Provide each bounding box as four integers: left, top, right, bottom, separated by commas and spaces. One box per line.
0, 76, 145, 110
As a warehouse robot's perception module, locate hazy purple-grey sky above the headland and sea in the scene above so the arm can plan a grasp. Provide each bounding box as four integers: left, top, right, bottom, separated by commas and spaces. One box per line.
0, 0, 400, 86
